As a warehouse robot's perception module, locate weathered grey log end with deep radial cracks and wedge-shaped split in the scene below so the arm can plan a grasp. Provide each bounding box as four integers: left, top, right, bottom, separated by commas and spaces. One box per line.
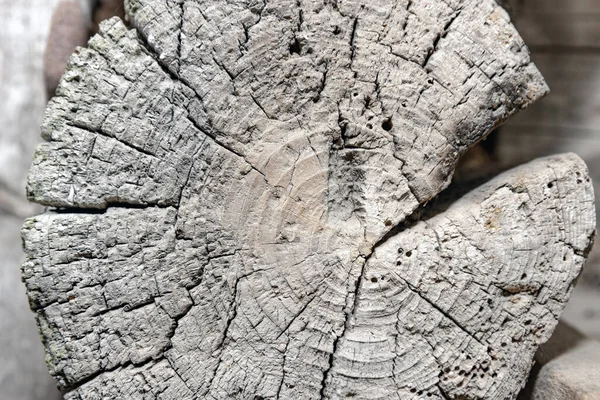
23, 0, 594, 399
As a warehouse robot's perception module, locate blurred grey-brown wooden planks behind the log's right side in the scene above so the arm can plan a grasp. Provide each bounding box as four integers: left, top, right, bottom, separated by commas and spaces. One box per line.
498, 0, 600, 339
